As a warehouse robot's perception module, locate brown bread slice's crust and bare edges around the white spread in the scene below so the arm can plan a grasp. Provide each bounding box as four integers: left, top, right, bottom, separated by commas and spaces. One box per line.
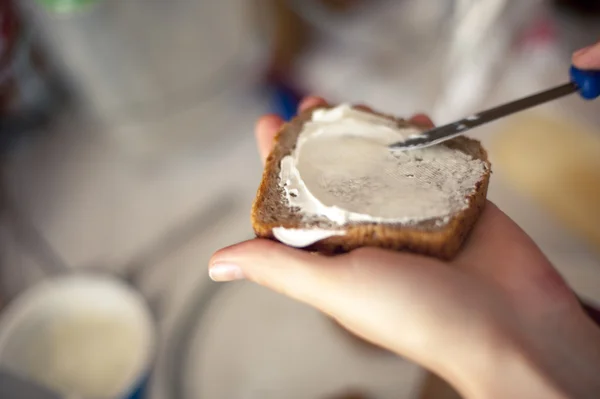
251, 107, 491, 259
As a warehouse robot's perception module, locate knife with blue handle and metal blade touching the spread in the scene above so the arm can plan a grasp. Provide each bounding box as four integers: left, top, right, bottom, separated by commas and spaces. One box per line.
390, 66, 600, 151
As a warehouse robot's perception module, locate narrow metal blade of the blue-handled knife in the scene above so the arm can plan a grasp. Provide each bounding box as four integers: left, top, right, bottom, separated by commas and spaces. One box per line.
390, 83, 579, 150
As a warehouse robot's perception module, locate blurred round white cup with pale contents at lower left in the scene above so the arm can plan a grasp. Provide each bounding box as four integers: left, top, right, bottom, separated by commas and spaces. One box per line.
0, 274, 156, 399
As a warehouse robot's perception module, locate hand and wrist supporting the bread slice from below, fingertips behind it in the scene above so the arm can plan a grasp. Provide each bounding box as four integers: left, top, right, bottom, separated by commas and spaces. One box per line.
209, 98, 600, 398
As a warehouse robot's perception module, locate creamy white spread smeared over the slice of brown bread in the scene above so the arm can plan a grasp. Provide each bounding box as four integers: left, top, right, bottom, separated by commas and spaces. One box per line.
277, 105, 487, 246
